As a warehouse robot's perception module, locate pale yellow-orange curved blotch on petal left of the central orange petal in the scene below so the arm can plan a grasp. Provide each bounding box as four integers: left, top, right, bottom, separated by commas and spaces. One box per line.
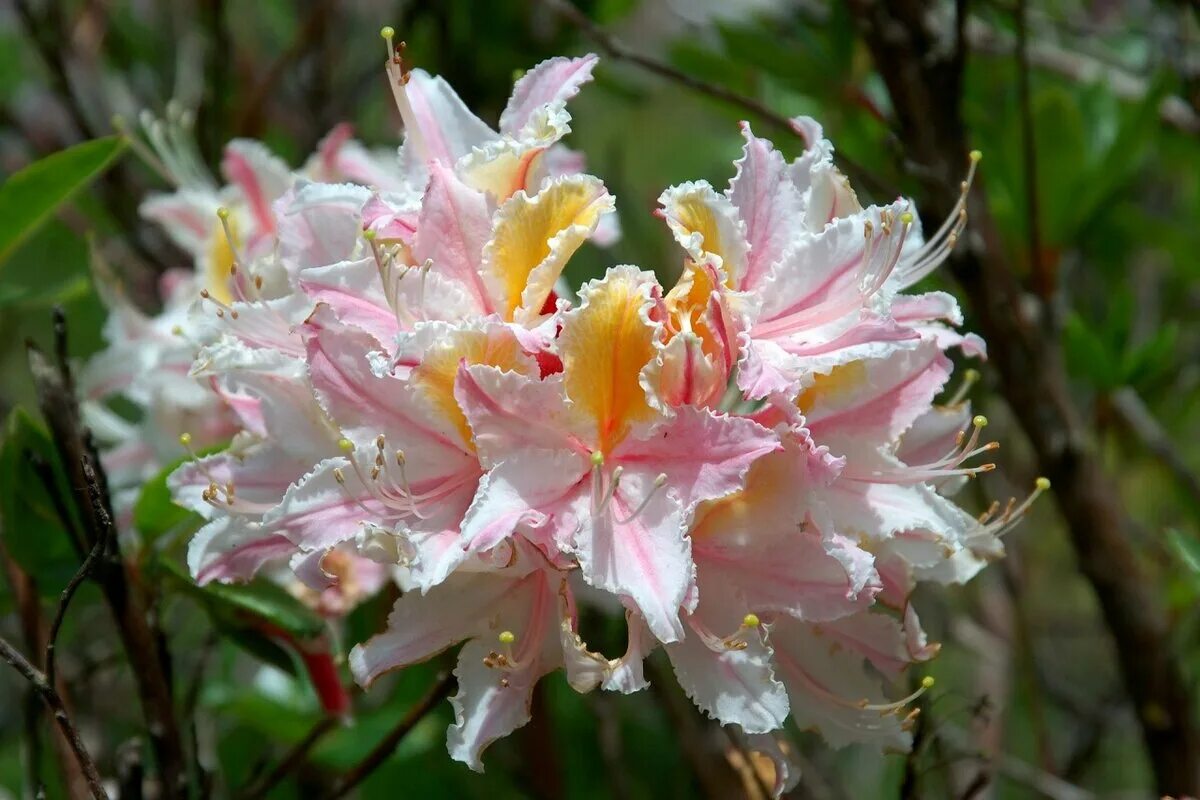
412, 329, 538, 449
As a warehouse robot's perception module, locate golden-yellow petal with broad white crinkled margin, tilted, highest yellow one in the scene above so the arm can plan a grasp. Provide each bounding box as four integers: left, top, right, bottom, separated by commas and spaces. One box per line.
484, 175, 613, 321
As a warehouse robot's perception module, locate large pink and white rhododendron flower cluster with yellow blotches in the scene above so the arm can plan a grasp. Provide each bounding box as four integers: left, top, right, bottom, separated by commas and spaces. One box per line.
89, 30, 1045, 786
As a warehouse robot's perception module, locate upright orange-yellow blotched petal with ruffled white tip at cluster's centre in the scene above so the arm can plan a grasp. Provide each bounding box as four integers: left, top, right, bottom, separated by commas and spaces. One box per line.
558, 266, 660, 453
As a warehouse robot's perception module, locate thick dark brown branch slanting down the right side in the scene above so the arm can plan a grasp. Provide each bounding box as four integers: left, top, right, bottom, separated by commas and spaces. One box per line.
851, 0, 1200, 795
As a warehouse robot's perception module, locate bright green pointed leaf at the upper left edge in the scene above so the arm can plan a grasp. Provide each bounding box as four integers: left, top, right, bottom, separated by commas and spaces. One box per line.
0, 136, 126, 264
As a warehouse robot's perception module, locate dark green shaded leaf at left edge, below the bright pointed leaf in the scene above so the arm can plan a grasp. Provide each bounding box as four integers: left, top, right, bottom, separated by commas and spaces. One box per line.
0, 408, 79, 595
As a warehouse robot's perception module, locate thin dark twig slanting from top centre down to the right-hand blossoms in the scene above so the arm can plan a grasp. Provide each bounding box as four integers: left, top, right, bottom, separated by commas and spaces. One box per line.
545, 0, 896, 197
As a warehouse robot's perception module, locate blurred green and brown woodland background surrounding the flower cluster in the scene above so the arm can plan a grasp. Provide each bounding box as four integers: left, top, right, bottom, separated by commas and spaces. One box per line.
0, 0, 1200, 800
